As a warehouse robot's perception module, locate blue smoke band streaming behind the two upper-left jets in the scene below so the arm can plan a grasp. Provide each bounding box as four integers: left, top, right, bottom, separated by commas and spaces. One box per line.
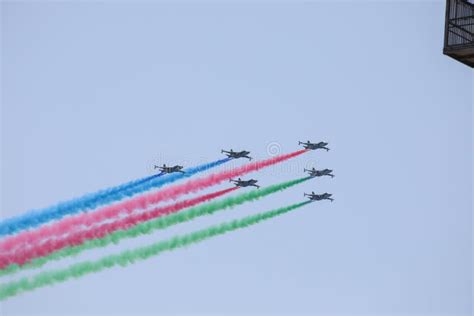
0, 158, 230, 236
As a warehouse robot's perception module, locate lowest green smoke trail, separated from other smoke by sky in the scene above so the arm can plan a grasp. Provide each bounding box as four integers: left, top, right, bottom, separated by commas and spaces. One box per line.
0, 201, 310, 300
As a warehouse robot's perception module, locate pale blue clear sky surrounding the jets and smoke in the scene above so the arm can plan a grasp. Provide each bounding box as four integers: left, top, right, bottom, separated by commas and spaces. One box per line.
0, 1, 474, 316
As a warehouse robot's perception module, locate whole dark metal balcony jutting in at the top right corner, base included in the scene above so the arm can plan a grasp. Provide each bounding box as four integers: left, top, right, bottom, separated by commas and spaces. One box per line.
443, 0, 474, 68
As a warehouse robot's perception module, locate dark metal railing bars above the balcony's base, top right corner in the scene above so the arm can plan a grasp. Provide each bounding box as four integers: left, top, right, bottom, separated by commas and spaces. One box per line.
444, 0, 474, 48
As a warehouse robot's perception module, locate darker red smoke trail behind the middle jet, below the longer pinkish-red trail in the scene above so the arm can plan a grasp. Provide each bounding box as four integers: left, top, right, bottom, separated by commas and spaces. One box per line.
0, 187, 238, 268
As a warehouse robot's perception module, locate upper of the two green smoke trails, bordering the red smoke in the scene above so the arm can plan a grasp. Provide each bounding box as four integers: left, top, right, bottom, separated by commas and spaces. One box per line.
0, 177, 311, 276
